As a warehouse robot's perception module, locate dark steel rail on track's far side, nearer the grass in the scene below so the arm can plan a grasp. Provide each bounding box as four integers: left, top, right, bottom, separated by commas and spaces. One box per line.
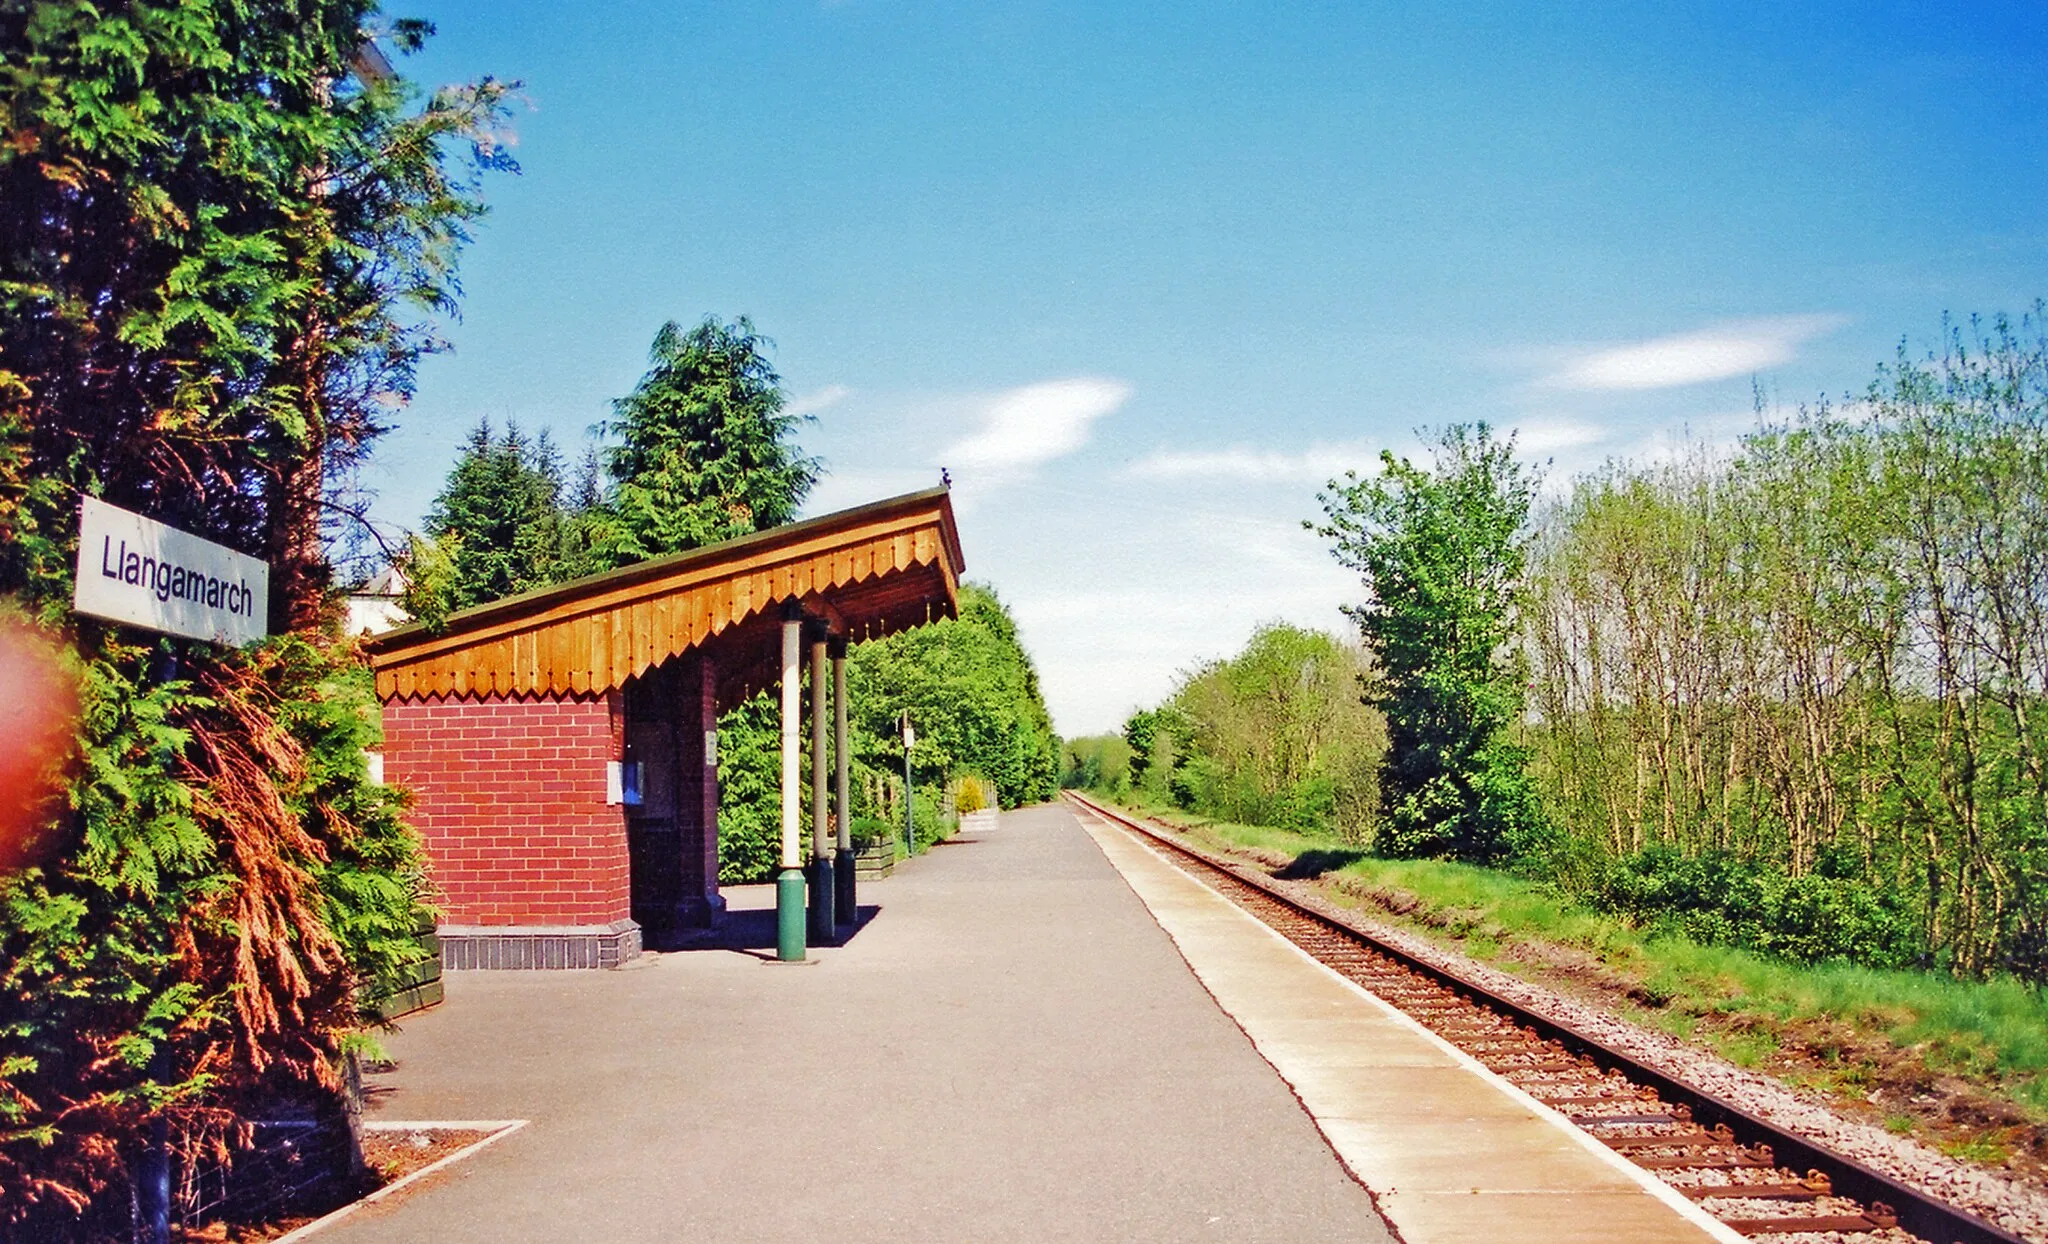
1063, 791, 2028, 1244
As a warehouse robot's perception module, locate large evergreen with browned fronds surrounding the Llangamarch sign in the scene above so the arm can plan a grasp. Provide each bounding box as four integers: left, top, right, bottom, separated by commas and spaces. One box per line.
0, 9, 508, 1240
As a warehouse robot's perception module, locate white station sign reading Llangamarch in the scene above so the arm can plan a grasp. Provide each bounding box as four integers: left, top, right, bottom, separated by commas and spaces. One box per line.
72, 496, 270, 648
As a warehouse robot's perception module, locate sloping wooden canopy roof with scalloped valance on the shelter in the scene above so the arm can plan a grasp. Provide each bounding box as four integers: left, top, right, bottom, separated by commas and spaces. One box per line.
365, 488, 965, 707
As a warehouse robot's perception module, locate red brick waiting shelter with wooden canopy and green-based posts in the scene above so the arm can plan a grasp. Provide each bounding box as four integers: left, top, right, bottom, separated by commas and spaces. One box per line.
365, 488, 963, 967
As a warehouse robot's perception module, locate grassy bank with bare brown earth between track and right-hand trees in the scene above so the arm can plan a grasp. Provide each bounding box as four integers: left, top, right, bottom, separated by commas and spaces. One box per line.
1105, 807, 2048, 1178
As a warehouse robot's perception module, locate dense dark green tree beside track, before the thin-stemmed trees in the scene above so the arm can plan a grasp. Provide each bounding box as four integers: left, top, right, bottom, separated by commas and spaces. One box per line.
1317, 424, 1544, 863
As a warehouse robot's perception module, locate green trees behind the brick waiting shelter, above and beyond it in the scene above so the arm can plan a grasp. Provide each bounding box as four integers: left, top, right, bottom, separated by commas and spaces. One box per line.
406, 318, 1059, 881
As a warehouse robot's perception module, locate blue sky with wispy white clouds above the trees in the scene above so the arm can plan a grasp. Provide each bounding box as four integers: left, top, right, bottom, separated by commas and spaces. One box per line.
367, 0, 2048, 734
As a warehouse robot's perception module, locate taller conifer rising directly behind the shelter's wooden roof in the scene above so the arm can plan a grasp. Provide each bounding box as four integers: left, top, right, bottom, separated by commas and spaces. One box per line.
602, 316, 819, 566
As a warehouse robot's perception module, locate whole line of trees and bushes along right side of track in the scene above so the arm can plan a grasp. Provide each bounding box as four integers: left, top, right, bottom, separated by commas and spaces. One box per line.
1065, 309, 2048, 982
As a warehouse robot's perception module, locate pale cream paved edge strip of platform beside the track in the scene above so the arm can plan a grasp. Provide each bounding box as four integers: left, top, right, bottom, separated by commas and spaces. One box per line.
1075, 810, 1743, 1244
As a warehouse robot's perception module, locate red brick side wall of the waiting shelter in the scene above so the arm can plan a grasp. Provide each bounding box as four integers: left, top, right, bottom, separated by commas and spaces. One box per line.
383, 695, 631, 924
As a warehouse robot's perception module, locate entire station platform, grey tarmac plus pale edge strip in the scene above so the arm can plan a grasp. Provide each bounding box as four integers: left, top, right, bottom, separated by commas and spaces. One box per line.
331, 805, 1720, 1244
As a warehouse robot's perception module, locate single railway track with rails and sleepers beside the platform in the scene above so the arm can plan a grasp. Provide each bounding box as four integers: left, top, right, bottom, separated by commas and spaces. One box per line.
1067, 791, 2025, 1244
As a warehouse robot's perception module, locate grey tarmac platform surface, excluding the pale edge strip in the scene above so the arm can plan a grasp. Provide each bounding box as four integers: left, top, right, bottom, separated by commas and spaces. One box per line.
344, 805, 1417, 1244
